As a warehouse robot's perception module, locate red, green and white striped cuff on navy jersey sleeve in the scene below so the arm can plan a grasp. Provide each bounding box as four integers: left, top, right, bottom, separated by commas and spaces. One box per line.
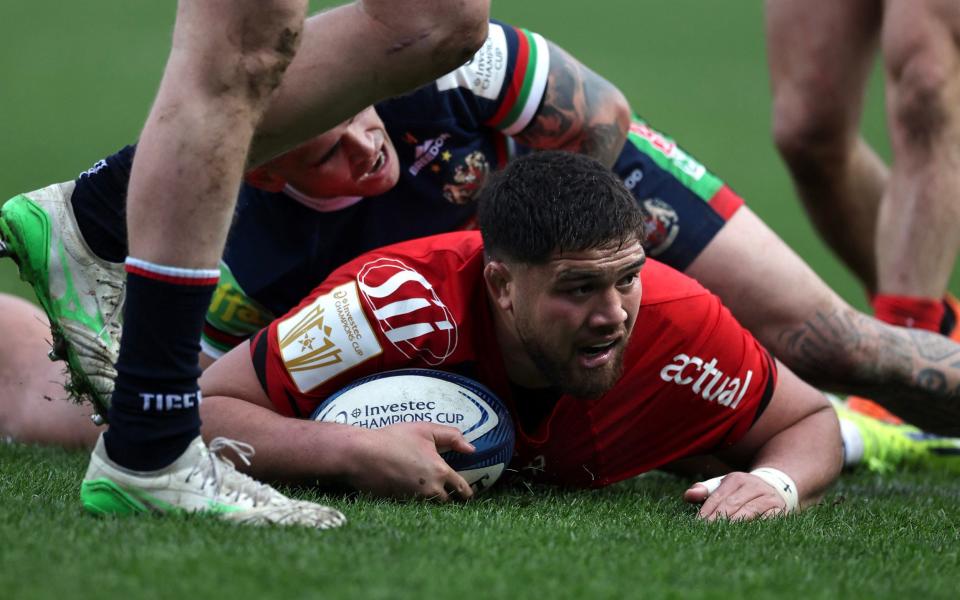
487, 28, 550, 135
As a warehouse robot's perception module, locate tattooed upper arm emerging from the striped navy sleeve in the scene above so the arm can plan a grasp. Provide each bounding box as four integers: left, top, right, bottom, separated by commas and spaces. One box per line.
516, 42, 630, 166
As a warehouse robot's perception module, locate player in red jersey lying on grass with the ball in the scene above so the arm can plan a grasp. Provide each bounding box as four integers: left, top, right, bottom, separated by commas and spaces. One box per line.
186, 152, 842, 519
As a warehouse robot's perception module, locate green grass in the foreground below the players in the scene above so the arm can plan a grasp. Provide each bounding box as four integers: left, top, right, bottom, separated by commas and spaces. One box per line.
0, 445, 960, 599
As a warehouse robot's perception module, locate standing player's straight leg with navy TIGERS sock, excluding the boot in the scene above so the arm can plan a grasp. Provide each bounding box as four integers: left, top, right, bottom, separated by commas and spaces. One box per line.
104, 0, 307, 471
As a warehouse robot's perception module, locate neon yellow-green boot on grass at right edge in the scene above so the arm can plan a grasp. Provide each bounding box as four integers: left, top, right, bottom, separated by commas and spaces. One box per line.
832, 399, 960, 473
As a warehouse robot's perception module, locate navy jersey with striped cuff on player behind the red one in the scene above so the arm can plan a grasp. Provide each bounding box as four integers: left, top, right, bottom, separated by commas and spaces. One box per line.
202, 22, 550, 357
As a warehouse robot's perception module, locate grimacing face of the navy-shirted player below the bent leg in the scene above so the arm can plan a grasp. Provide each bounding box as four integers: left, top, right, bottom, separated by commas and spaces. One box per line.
268, 106, 400, 198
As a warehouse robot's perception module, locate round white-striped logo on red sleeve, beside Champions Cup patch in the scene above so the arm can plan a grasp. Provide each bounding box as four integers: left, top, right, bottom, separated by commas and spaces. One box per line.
357, 258, 458, 366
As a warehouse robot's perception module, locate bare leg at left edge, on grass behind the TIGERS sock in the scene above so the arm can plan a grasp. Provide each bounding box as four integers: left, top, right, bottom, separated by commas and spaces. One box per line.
0, 294, 100, 448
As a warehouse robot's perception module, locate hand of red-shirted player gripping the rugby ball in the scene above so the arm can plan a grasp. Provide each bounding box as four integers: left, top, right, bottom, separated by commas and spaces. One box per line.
347, 423, 474, 502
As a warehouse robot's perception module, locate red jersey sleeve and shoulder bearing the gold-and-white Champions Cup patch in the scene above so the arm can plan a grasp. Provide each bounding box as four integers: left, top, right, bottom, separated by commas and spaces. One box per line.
250, 232, 482, 417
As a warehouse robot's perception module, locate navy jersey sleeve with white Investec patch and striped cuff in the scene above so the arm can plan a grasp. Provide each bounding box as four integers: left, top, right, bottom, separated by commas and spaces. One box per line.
435, 21, 550, 135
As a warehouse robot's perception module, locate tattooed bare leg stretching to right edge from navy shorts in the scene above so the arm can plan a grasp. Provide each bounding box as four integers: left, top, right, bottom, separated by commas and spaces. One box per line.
686, 207, 960, 436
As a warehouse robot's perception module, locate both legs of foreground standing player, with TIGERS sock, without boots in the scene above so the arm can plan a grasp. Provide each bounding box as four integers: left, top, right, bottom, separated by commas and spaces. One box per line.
105, 0, 487, 470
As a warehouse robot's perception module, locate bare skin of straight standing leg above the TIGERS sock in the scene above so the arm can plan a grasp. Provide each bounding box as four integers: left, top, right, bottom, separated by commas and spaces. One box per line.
127, 0, 306, 268
